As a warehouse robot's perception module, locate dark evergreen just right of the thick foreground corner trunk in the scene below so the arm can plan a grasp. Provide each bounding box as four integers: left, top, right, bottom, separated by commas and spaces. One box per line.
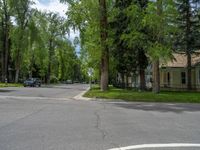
110, 0, 140, 88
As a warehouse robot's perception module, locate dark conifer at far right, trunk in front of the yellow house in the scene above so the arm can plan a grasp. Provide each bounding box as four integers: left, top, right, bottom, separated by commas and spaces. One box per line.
175, 0, 200, 90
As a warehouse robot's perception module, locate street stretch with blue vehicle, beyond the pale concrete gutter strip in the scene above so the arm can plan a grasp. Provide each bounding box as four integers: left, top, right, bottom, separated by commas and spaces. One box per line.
0, 84, 89, 98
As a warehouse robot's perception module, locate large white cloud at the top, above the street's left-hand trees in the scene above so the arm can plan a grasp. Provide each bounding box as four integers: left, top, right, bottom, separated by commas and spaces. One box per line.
32, 0, 68, 17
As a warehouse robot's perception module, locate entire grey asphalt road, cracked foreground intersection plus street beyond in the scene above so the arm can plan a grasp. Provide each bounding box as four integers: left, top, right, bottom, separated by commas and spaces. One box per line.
0, 85, 200, 150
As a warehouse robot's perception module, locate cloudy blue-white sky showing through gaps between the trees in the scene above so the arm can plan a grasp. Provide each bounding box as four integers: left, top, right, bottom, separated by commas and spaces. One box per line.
32, 0, 80, 52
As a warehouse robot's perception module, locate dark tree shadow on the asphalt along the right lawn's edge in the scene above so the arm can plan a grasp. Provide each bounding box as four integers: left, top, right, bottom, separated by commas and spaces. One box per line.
115, 103, 200, 113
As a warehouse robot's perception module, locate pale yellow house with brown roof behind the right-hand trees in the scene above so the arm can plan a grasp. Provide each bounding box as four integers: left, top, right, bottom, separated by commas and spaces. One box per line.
160, 53, 200, 89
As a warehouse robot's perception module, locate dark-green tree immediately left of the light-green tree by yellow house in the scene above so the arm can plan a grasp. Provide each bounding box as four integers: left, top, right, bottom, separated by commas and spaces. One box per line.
117, 0, 148, 90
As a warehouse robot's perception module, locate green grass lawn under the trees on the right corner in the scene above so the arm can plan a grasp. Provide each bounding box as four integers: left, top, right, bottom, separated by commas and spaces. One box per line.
84, 87, 200, 103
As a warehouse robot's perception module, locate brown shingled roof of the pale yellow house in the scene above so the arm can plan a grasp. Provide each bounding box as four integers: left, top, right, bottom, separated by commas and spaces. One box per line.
162, 53, 200, 68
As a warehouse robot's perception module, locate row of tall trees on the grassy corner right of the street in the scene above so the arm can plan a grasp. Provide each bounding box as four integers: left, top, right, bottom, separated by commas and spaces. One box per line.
61, 0, 200, 93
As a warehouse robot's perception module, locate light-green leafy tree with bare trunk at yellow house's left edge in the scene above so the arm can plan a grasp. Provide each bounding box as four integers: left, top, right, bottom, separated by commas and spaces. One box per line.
143, 0, 177, 93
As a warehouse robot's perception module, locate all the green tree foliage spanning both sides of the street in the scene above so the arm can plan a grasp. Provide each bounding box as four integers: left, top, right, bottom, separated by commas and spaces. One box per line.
0, 0, 200, 88
